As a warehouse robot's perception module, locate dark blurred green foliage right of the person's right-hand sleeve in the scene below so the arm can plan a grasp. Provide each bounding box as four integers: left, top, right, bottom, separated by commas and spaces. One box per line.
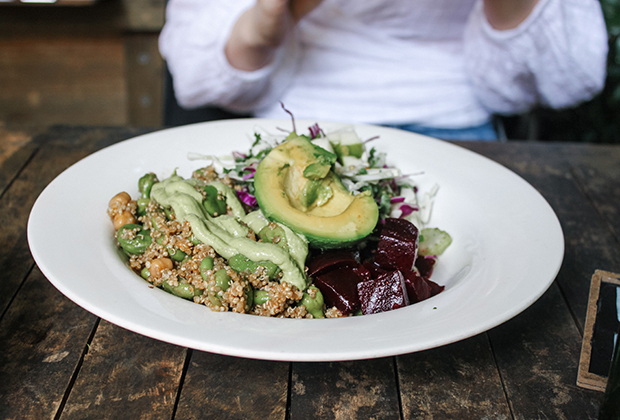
528, 0, 620, 143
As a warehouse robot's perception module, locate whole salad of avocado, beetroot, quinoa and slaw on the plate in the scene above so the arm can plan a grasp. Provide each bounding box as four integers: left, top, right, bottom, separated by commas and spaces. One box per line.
107, 121, 451, 318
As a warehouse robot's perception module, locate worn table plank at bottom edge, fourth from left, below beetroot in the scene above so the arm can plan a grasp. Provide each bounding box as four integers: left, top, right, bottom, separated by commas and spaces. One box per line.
290, 357, 400, 420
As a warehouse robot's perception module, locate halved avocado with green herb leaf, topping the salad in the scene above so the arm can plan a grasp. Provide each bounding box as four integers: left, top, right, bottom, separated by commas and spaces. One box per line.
254, 136, 379, 249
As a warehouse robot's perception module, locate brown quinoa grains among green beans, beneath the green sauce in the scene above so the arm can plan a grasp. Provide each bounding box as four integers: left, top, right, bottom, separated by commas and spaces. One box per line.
107, 167, 322, 318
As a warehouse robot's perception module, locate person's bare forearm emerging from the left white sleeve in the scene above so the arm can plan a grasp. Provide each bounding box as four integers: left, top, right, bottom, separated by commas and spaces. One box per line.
225, 0, 323, 71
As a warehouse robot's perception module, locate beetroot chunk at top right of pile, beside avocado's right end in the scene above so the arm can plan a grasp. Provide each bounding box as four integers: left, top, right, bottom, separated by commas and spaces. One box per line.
375, 218, 420, 271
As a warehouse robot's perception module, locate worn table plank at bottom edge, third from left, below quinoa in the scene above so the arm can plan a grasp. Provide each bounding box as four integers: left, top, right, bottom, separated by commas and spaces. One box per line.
175, 351, 289, 420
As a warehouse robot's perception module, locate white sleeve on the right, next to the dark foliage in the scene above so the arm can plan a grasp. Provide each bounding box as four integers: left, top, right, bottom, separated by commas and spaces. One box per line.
464, 0, 607, 114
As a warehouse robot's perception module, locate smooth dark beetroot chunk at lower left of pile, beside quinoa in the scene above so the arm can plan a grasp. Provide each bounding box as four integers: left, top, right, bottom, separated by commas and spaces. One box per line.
314, 268, 363, 315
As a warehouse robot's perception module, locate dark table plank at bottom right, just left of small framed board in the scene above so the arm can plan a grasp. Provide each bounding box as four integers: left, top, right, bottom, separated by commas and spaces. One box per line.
489, 284, 601, 420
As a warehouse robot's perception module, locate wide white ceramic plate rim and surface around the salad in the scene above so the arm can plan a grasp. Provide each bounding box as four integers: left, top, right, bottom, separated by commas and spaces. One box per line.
28, 119, 564, 361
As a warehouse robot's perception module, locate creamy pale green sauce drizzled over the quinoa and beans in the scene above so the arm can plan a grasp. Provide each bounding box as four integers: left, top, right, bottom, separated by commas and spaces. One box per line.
151, 174, 308, 291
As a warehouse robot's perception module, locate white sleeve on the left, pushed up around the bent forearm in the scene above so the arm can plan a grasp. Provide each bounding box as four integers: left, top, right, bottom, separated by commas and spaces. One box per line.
159, 0, 296, 112
